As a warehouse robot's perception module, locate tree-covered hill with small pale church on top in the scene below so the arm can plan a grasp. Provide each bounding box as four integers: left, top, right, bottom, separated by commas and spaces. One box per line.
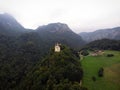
20, 46, 84, 90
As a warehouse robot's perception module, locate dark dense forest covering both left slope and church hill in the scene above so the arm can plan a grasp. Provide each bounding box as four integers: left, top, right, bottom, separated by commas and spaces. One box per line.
0, 39, 86, 90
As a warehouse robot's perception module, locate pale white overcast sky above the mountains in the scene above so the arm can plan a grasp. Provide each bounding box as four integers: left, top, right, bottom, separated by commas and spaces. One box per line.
0, 0, 120, 33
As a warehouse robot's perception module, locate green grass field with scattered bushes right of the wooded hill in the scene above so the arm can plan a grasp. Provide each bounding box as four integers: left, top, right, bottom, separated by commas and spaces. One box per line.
81, 51, 120, 90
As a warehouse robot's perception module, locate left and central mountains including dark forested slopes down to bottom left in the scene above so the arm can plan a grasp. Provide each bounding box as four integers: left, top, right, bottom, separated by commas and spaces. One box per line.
0, 13, 85, 90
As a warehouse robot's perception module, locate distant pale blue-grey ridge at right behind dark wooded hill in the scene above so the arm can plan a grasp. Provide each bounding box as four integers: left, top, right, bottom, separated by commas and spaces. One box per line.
79, 27, 120, 42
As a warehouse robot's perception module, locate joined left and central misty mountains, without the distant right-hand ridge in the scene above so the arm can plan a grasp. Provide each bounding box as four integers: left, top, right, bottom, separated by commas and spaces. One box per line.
0, 13, 85, 48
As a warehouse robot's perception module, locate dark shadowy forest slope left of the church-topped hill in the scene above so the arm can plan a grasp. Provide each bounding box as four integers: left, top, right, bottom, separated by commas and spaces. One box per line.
0, 35, 46, 90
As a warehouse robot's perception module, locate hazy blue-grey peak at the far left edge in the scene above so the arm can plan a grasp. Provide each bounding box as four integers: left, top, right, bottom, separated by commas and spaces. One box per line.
0, 13, 26, 36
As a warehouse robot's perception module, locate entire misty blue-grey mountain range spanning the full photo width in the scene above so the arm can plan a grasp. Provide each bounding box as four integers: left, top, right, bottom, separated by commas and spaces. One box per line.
0, 13, 120, 48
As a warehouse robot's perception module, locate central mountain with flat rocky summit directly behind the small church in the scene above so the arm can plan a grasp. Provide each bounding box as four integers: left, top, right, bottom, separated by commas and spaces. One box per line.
36, 23, 85, 48
